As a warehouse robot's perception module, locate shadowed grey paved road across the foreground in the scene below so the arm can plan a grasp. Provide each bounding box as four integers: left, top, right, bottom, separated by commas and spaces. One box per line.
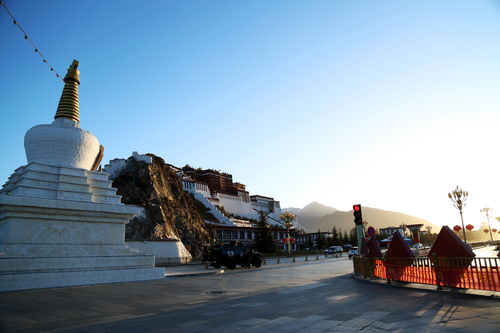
0, 257, 500, 333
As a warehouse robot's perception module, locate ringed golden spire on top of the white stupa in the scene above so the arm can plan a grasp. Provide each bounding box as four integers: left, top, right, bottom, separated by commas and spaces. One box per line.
54, 60, 80, 122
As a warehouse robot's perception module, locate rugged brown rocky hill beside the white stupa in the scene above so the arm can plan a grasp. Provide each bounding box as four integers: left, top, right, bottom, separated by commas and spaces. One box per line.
113, 154, 213, 255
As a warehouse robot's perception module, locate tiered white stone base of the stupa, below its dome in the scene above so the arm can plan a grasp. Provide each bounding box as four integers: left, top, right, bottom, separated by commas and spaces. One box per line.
0, 163, 165, 291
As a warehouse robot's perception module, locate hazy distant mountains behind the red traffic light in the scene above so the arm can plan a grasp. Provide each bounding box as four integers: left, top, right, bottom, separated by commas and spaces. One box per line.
282, 201, 440, 232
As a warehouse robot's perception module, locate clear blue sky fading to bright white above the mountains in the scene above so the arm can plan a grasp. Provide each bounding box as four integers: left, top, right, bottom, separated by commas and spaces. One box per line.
0, 0, 500, 231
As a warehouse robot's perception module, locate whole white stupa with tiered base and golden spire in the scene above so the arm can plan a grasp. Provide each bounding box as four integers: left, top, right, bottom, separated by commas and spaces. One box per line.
0, 60, 164, 291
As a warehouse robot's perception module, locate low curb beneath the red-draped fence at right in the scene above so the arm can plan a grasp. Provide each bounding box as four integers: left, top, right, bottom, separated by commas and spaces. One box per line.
351, 273, 500, 299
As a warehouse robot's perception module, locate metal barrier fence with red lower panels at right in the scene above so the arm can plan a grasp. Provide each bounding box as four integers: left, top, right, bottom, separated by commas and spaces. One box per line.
353, 256, 500, 291
